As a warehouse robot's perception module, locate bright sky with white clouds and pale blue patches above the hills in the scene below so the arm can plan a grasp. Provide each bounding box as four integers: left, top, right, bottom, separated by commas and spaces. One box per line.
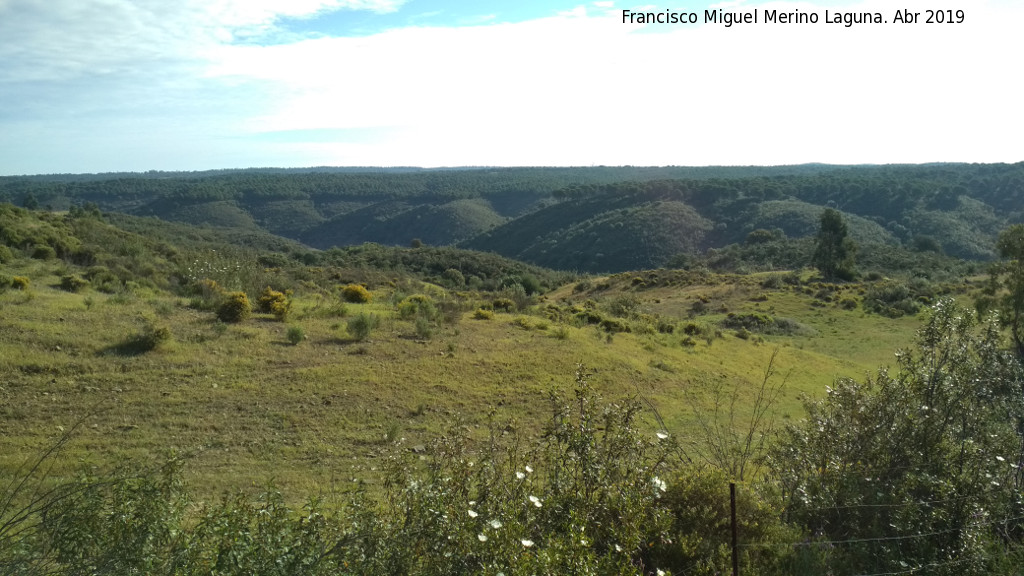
0, 0, 1024, 175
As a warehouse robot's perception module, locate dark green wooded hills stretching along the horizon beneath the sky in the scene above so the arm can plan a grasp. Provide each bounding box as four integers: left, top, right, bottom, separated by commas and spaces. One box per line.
0, 163, 1024, 273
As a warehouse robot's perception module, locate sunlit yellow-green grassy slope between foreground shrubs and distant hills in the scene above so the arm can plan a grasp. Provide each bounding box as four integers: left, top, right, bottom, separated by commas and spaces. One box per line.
0, 255, 933, 494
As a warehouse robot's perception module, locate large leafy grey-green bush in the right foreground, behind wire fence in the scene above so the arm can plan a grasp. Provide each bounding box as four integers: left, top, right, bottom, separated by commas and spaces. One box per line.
772, 300, 1024, 574
